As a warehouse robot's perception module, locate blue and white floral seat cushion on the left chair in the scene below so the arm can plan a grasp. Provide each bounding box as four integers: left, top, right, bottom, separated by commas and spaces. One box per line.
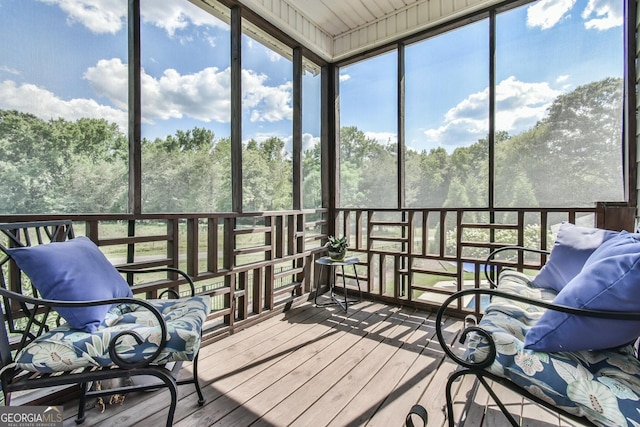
15, 296, 211, 372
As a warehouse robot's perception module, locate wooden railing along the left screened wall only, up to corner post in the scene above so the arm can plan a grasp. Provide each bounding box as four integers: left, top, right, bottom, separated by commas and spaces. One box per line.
0, 209, 328, 342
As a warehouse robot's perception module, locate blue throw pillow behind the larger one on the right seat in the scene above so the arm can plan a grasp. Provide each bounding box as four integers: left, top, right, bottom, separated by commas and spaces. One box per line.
533, 222, 618, 292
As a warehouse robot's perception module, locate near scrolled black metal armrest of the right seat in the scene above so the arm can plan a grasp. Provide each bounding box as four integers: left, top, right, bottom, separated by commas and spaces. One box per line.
436, 288, 640, 369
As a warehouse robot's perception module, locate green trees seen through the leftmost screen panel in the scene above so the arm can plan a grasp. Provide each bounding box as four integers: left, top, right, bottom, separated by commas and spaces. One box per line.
0, 110, 128, 214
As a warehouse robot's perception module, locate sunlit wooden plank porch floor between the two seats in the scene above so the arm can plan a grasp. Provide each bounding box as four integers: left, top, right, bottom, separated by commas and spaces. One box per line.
57, 301, 584, 427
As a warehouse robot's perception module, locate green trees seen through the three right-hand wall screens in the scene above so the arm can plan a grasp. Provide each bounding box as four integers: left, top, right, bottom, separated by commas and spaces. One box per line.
340, 78, 624, 211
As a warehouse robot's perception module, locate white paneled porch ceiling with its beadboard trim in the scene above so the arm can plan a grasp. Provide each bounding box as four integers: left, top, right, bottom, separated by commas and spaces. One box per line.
240, 0, 499, 62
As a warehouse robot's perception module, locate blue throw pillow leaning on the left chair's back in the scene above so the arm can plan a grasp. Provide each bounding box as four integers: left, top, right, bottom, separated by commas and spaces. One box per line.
8, 237, 132, 332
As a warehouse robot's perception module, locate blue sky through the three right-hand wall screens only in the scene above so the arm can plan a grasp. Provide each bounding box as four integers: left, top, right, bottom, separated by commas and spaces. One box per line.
340, 0, 623, 151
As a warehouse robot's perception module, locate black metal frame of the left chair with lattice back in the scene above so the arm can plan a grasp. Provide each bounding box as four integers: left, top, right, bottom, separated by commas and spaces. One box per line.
0, 221, 205, 427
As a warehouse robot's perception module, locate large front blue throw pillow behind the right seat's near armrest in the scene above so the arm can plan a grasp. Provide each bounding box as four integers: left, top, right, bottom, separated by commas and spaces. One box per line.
525, 232, 640, 352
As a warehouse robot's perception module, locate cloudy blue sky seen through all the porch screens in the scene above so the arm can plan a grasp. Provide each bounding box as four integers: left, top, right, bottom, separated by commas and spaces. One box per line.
0, 0, 622, 154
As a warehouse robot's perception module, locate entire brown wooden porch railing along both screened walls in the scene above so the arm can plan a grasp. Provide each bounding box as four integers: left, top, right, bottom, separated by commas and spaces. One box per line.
0, 204, 635, 342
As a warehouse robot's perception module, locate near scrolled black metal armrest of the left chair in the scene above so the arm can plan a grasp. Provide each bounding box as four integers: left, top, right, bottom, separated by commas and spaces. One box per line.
0, 287, 167, 368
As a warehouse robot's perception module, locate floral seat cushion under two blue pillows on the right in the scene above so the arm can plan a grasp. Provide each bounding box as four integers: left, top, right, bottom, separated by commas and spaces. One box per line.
467, 271, 640, 427
